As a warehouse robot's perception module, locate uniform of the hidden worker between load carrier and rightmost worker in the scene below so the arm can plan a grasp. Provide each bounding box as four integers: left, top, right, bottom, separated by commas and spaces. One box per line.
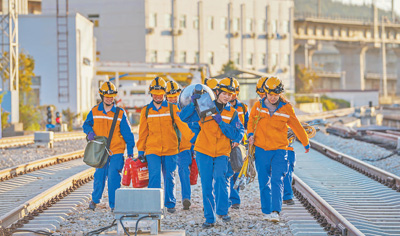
227, 99, 249, 206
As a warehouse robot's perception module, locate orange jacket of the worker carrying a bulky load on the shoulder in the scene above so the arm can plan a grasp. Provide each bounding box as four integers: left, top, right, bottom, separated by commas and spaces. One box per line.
194, 103, 244, 157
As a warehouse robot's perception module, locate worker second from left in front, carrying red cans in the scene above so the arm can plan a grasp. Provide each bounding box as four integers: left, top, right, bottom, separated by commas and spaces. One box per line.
138, 77, 193, 213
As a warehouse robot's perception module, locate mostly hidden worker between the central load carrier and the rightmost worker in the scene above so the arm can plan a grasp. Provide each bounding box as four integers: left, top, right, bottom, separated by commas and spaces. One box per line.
227, 78, 249, 209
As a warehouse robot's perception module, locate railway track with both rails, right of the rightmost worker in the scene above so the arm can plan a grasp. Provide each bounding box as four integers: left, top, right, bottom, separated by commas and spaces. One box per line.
293, 141, 400, 235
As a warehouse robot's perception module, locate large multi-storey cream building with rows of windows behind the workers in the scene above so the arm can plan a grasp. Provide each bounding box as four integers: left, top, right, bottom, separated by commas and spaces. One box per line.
42, 0, 294, 94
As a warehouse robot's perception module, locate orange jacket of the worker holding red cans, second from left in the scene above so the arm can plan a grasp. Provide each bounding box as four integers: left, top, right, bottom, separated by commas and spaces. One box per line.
137, 101, 194, 156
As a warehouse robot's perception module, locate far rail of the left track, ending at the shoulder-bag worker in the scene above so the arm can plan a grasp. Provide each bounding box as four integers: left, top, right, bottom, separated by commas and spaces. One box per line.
0, 150, 84, 182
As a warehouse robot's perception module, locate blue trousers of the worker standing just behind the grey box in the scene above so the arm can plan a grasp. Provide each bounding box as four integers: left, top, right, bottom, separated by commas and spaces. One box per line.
146, 154, 178, 208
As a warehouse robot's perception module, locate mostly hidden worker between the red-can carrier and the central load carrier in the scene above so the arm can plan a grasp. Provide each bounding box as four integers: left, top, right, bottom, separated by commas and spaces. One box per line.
166, 81, 192, 210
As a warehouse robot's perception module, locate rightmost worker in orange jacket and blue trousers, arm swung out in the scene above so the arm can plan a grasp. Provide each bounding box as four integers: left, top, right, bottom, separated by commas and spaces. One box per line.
248, 77, 310, 222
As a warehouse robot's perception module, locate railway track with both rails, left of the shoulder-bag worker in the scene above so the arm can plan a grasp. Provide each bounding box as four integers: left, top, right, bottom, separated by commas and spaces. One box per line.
0, 150, 91, 235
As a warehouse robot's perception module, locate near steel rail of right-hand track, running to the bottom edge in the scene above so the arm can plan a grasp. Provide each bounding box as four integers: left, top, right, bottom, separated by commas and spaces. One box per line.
292, 174, 364, 236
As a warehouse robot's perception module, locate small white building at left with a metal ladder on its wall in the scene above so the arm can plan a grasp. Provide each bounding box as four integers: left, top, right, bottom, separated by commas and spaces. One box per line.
19, 14, 95, 114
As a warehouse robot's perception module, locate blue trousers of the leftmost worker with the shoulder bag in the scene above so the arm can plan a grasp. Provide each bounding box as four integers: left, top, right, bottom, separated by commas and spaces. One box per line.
92, 153, 124, 208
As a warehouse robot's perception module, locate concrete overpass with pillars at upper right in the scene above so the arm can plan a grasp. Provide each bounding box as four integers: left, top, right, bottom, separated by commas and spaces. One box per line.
293, 10, 400, 95
